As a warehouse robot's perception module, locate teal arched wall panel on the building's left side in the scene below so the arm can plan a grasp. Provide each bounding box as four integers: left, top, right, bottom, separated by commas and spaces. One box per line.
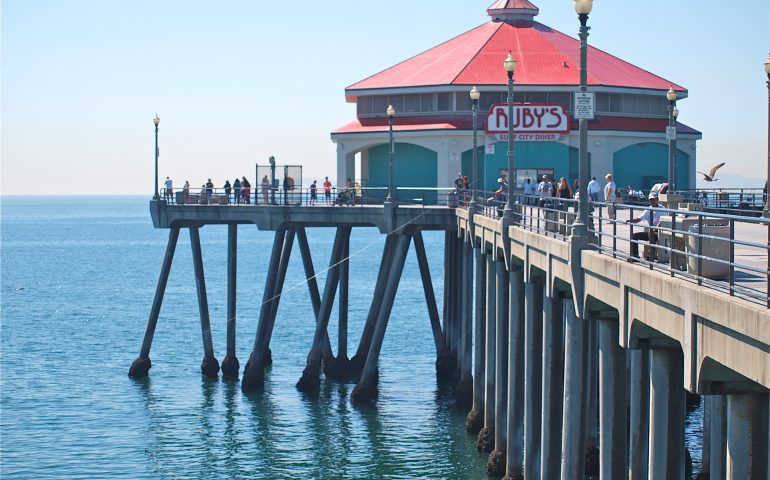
368, 143, 438, 202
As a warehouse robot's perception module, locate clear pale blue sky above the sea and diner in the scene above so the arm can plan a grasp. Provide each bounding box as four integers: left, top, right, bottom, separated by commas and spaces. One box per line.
0, 0, 770, 194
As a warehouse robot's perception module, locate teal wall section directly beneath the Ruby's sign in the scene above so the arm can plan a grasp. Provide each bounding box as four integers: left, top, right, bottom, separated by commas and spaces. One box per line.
462, 142, 590, 190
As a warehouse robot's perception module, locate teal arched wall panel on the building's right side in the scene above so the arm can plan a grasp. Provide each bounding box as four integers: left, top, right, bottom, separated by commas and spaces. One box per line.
612, 142, 690, 190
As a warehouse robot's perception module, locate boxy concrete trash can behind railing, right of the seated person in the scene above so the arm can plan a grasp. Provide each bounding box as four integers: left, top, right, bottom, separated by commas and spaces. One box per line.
687, 225, 732, 279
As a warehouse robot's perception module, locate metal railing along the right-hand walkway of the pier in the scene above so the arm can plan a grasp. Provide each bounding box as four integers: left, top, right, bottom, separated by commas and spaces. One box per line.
461, 192, 770, 308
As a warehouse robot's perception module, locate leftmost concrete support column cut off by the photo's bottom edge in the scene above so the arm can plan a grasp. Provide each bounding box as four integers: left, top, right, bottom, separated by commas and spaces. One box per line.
505, 267, 525, 480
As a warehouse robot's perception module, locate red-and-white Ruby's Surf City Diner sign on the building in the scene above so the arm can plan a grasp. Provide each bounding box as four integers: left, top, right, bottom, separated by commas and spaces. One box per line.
486, 103, 569, 140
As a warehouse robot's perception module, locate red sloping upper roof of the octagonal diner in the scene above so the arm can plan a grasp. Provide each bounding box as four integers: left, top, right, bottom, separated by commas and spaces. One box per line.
346, 21, 686, 97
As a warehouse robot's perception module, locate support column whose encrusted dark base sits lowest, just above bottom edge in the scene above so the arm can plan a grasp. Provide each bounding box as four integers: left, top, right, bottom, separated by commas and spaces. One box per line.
487, 261, 508, 477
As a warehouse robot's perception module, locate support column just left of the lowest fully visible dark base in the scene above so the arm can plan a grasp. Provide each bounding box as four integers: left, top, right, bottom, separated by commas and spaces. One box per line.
476, 253, 497, 453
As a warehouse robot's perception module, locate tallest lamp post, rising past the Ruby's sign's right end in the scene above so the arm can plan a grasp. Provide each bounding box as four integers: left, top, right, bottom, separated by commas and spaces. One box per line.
572, 0, 594, 241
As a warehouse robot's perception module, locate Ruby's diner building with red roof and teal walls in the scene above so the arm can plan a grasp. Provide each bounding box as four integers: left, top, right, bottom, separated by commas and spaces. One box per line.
331, 0, 701, 197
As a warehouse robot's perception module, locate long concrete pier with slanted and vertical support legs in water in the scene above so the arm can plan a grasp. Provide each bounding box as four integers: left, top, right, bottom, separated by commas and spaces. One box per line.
129, 189, 770, 479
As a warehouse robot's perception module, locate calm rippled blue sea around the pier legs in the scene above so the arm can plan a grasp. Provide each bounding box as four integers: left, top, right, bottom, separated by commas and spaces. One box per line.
0, 197, 700, 479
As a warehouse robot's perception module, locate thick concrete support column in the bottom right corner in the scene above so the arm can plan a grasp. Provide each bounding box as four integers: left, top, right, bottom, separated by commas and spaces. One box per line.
727, 393, 768, 480
